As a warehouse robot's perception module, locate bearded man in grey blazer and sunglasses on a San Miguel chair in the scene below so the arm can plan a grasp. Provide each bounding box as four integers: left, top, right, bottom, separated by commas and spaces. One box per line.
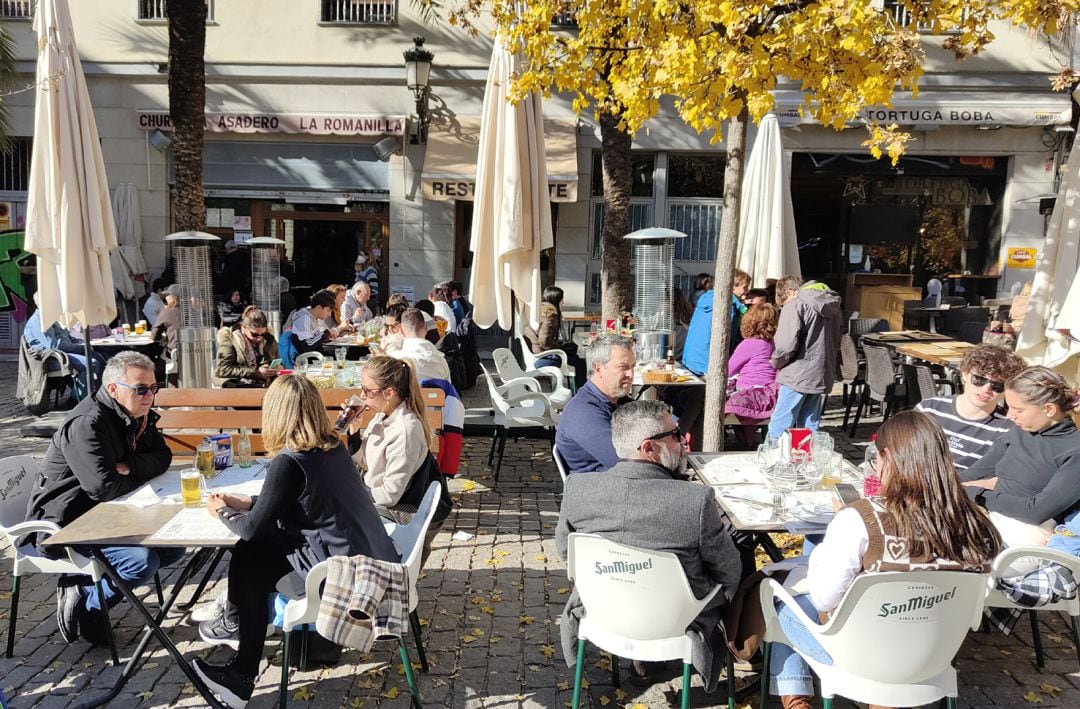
555, 401, 754, 692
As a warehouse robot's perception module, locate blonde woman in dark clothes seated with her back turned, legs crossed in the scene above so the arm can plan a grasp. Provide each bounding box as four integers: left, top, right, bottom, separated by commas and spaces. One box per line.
194, 374, 400, 707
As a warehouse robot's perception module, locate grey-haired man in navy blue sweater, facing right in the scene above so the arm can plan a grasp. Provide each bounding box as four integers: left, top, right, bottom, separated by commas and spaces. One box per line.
555, 333, 635, 472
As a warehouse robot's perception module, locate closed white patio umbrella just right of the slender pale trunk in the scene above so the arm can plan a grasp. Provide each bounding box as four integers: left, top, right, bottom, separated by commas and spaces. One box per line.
735, 113, 802, 287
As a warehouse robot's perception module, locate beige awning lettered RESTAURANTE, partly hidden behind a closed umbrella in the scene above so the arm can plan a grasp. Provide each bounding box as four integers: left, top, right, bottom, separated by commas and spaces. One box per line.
420, 116, 578, 202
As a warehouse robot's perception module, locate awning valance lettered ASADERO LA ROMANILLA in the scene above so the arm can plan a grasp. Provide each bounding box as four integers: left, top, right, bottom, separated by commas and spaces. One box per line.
137, 110, 405, 136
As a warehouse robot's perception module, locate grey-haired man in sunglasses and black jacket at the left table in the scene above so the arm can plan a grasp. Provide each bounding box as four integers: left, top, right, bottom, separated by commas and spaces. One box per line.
27, 351, 184, 644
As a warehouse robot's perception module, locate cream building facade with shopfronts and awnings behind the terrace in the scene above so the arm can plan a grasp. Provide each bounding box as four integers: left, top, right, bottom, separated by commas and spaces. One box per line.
0, 0, 1074, 344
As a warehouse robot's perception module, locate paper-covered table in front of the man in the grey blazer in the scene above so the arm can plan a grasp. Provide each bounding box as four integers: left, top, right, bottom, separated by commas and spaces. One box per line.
689, 452, 862, 561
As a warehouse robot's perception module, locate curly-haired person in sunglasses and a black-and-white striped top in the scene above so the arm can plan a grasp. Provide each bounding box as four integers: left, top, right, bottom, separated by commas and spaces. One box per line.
916, 345, 1025, 470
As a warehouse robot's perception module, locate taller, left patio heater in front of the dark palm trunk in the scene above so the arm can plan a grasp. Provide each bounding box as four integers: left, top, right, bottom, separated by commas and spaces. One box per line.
165, 231, 220, 389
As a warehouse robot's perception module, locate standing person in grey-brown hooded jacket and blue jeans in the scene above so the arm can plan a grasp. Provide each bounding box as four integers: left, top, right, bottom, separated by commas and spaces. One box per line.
769, 276, 841, 437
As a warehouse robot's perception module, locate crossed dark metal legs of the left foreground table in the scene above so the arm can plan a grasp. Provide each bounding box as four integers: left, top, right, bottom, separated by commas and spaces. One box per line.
77, 548, 231, 709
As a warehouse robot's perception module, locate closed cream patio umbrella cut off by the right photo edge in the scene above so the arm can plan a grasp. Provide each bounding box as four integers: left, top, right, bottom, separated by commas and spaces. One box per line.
1016, 89, 1080, 385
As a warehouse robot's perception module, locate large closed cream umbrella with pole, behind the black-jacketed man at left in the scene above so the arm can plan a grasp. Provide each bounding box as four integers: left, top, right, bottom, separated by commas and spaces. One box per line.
26, 0, 117, 390
